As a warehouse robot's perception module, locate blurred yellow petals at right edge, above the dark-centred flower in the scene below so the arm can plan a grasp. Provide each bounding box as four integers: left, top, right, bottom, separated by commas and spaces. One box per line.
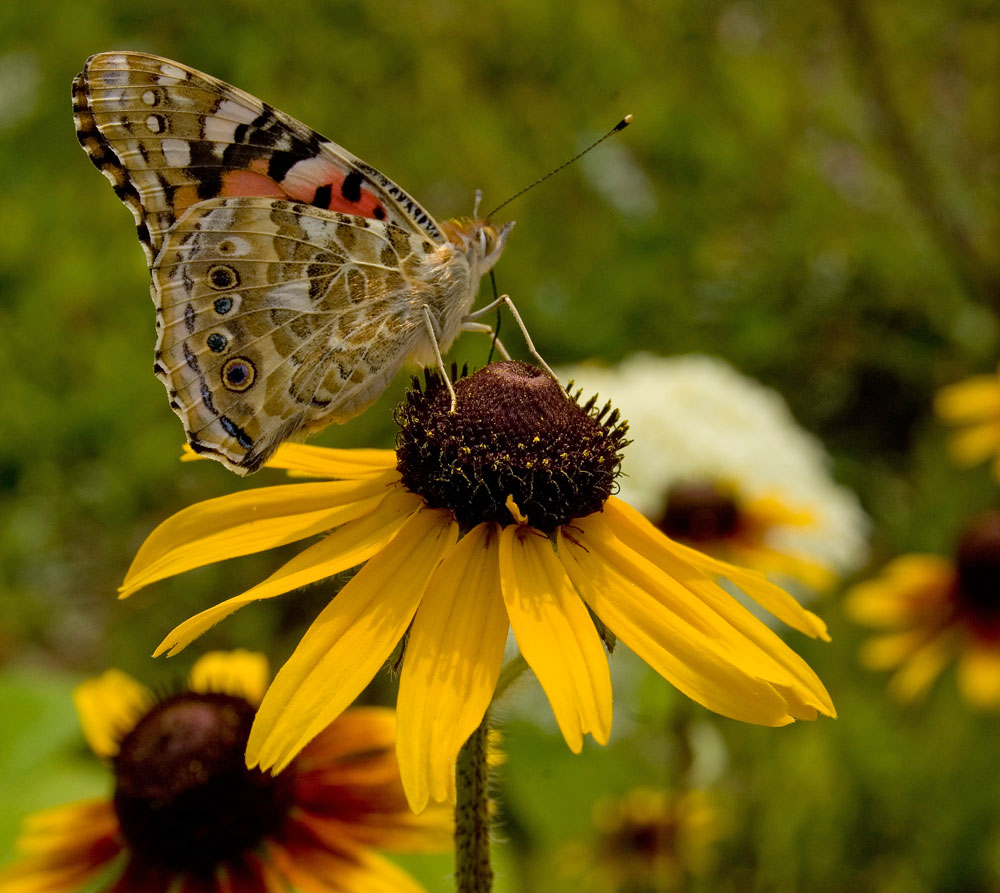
934, 362, 1000, 479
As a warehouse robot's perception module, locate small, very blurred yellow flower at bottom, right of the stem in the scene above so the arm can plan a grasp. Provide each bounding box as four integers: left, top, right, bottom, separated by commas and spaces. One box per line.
562, 787, 722, 893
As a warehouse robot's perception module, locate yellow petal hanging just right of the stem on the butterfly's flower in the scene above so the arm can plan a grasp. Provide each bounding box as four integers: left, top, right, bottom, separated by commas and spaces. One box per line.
500, 524, 611, 753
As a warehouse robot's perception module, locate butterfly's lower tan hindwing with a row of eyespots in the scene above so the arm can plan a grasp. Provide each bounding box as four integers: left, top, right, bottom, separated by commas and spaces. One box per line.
152, 198, 442, 474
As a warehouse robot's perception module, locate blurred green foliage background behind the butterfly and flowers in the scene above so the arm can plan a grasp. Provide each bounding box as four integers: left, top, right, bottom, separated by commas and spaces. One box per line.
0, 0, 1000, 891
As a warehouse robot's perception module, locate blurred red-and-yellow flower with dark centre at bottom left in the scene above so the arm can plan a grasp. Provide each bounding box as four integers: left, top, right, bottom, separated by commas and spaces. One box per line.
0, 651, 450, 893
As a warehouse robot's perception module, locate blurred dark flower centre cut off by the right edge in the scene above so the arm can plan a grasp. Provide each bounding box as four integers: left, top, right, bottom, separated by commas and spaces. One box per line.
954, 511, 1000, 640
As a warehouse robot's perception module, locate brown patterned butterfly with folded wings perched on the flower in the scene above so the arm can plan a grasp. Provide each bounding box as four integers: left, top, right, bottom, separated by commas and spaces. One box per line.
73, 52, 513, 475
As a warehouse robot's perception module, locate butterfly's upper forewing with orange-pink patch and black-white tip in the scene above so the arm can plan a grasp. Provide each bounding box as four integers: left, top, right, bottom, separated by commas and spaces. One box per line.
73, 52, 443, 266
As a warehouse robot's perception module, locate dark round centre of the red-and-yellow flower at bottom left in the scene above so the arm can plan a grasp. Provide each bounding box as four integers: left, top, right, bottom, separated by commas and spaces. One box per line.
114, 692, 293, 873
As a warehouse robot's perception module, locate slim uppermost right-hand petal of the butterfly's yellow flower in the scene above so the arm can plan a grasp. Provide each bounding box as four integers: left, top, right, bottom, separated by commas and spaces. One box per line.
604, 496, 830, 642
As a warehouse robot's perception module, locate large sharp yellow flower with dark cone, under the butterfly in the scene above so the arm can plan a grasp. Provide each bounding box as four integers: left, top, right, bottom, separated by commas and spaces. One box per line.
122, 363, 834, 811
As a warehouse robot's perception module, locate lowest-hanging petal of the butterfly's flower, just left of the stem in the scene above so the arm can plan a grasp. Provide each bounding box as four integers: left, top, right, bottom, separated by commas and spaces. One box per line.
396, 524, 509, 812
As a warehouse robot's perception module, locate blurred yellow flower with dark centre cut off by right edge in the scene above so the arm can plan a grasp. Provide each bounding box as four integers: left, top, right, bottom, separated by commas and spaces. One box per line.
845, 511, 1000, 709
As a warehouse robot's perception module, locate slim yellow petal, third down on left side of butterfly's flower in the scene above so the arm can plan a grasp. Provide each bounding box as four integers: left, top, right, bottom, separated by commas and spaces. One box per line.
153, 490, 422, 657
